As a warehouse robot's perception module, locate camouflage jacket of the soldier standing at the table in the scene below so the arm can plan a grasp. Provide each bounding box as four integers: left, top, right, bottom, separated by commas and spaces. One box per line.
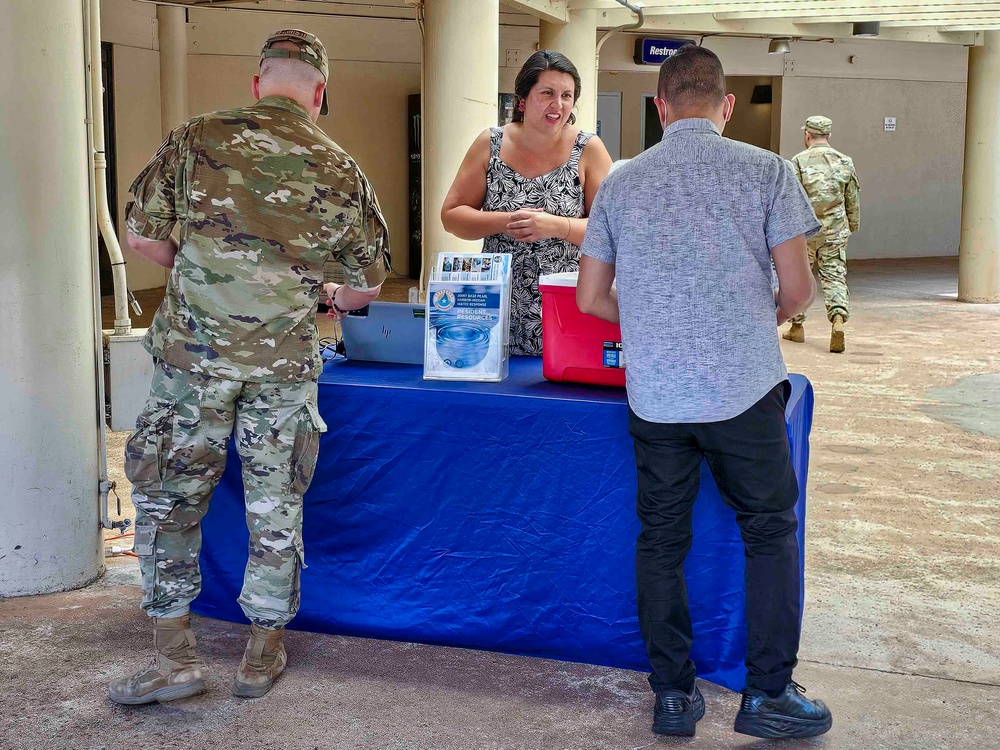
127, 96, 389, 382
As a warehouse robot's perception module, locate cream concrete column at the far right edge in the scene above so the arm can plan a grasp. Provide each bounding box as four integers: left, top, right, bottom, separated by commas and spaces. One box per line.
958, 31, 1000, 302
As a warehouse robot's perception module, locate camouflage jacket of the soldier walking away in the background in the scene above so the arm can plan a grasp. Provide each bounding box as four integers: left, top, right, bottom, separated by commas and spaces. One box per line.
792, 145, 861, 242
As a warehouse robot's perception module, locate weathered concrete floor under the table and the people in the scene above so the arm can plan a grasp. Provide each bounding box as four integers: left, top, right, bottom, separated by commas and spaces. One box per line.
0, 260, 1000, 750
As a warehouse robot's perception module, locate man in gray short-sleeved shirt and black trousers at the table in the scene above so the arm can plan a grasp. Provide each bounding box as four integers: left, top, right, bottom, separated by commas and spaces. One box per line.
577, 45, 832, 737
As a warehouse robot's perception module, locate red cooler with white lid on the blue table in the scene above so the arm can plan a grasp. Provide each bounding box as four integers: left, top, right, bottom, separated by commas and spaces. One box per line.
538, 271, 625, 387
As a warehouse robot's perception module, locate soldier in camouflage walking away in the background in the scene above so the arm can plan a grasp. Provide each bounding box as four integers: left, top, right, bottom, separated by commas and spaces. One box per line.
784, 115, 861, 352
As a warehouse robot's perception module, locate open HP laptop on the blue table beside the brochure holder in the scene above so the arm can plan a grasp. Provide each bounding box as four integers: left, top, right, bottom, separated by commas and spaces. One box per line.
340, 302, 426, 365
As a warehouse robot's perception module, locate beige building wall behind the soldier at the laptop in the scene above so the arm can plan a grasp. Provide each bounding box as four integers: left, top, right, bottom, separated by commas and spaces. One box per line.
102, 0, 424, 289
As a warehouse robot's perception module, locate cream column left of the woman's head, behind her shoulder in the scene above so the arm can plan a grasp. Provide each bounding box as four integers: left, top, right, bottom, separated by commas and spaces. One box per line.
421, 0, 500, 279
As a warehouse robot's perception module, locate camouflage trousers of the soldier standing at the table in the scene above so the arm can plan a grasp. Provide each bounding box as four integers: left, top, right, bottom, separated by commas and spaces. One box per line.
125, 361, 326, 629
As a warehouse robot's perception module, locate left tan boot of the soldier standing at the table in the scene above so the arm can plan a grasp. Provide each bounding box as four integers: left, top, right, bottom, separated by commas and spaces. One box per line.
108, 615, 206, 706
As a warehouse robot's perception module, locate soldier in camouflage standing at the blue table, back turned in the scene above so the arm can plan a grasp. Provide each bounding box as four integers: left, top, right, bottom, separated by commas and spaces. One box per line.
109, 29, 389, 704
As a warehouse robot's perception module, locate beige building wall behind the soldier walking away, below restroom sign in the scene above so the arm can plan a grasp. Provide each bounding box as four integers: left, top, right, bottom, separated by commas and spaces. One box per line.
601, 34, 968, 258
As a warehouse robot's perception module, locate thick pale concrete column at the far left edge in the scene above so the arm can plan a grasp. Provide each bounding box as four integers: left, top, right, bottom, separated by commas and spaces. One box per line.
0, 0, 104, 596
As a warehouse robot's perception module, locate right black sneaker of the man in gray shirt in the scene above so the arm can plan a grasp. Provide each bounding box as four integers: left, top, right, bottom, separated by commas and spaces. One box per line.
733, 682, 833, 739
